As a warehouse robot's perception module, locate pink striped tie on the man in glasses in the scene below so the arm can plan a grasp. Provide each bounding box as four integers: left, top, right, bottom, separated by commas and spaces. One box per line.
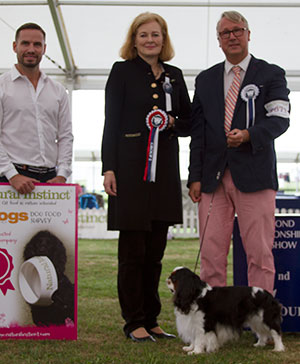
224, 66, 241, 135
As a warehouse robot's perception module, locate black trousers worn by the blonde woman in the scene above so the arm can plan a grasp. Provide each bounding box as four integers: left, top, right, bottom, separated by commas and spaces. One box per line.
118, 221, 168, 336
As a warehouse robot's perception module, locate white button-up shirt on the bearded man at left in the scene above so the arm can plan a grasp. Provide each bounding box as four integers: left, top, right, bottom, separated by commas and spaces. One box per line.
0, 66, 73, 179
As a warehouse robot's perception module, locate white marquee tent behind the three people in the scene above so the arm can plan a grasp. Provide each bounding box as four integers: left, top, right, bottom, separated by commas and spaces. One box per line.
0, 0, 300, 191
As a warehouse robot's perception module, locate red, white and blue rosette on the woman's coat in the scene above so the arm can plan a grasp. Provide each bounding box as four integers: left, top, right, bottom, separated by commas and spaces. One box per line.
144, 109, 168, 182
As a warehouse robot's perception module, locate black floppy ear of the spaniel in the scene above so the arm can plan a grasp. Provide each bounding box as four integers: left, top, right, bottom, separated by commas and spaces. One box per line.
174, 272, 201, 314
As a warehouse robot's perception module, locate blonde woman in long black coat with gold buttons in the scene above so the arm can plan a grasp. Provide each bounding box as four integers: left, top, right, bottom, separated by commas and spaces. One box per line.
102, 13, 190, 342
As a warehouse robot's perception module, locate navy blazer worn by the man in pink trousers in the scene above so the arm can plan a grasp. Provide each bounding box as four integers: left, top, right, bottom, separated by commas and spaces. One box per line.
188, 56, 289, 193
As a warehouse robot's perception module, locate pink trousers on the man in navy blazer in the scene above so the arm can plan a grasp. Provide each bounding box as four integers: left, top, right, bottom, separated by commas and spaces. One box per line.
199, 169, 276, 293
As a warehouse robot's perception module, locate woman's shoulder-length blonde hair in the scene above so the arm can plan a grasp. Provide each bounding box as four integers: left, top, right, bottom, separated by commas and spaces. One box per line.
120, 12, 174, 62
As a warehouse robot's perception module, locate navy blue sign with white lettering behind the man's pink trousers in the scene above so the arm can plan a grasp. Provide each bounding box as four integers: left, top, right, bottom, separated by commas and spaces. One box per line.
233, 214, 300, 332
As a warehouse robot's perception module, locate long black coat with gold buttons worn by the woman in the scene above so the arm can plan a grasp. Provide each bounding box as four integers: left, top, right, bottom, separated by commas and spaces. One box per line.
102, 57, 191, 231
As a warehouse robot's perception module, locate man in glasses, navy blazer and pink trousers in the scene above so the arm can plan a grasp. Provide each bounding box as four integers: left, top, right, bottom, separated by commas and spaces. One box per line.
188, 11, 289, 292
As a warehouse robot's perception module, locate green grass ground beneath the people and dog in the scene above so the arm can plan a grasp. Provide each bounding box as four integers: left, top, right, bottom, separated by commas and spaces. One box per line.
0, 240, 300, 364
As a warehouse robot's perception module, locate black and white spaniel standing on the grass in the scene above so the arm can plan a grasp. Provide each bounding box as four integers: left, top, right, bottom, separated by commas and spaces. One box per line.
167, 267, 284, 354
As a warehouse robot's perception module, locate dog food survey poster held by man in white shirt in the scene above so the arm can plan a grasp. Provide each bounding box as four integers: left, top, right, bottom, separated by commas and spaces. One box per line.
0, 184, 78, 340
